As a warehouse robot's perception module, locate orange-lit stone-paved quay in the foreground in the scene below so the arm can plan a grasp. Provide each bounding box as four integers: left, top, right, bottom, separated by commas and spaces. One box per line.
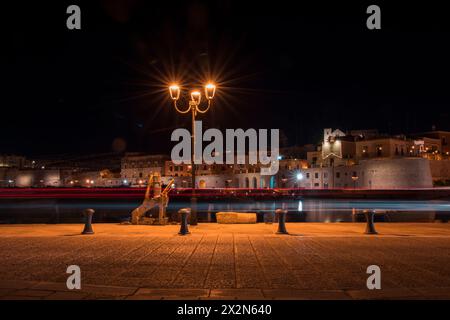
0, 223, 450, 300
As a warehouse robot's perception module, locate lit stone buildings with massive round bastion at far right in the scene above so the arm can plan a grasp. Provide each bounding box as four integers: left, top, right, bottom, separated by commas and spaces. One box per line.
300, 129, 450, 189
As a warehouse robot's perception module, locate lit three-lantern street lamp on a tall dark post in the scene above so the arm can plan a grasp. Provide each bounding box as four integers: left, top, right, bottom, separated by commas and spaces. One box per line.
169, 83, 216, 225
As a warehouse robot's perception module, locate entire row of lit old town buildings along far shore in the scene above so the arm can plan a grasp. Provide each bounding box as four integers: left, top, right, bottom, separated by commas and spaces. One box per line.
0, 128, 450, 189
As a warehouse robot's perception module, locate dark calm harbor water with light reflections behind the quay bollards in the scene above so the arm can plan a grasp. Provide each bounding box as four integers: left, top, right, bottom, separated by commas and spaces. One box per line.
0, 199, 450, 223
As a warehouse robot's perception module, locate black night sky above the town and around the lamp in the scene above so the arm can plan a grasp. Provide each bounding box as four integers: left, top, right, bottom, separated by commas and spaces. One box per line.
0, 0, 450, 156
